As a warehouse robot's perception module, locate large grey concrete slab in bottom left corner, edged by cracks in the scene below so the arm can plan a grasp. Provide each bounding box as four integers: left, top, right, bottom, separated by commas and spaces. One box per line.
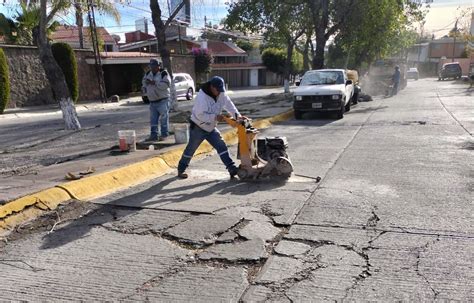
0, 225, 189, 302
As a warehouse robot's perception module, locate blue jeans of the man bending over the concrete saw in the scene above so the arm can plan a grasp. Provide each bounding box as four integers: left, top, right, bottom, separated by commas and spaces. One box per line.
178, 125, 237, 172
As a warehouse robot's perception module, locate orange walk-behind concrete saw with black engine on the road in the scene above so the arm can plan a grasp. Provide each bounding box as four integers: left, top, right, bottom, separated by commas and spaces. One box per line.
224, 117, 293, 180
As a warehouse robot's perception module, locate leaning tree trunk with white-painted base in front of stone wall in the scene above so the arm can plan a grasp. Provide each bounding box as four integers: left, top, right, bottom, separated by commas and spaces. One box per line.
38, 0, 81, 130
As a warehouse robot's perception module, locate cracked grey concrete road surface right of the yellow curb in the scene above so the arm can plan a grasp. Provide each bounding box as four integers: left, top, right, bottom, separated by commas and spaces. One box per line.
0, 79, 474, 302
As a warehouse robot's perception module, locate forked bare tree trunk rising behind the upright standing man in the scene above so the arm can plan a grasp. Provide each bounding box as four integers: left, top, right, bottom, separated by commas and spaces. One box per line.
150, 0, 190, 108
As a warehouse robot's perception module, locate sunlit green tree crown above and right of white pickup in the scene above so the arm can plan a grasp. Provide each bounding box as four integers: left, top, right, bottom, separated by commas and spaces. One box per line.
329, 0, 426, 68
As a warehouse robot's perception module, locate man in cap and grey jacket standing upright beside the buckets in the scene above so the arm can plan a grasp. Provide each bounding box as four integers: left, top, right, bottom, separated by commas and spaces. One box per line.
142, 59, 171, 141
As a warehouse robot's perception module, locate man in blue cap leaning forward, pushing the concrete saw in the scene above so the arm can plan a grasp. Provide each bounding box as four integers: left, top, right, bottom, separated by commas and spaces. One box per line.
178, 76, 240, 179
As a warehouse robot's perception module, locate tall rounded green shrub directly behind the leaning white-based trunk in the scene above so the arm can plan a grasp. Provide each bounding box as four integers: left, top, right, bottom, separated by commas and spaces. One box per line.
51, 43, 79, 102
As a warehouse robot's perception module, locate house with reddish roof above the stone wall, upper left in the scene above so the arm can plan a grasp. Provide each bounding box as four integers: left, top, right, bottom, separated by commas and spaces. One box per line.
50, 25, 119, 52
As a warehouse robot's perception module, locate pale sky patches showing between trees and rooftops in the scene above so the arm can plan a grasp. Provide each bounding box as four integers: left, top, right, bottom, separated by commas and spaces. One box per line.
0, 0, 474, 39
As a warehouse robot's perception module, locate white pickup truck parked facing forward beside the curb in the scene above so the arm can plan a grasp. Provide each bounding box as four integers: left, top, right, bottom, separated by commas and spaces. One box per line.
293, 69, 354, 119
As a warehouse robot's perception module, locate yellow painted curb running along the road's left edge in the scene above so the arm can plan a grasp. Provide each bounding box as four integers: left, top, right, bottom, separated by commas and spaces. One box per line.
0, 110, 293, 235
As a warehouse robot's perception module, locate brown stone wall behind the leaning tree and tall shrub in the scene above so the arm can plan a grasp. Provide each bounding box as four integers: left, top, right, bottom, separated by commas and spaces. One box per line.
1, 45, 99, 108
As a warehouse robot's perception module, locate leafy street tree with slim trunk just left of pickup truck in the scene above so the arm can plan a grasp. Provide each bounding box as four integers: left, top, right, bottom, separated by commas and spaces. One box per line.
226, 0, 310, 92
